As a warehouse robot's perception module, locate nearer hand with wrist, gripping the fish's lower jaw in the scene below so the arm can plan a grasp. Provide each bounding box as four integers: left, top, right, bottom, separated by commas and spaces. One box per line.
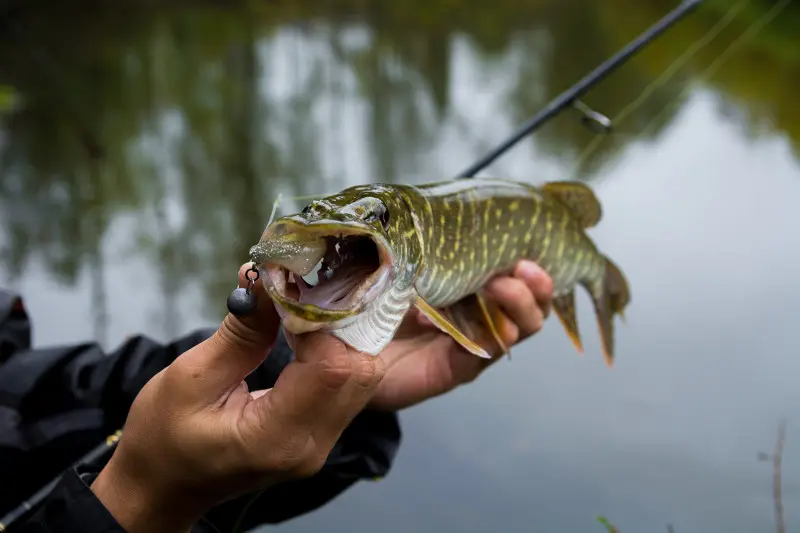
92, 265, 384, 533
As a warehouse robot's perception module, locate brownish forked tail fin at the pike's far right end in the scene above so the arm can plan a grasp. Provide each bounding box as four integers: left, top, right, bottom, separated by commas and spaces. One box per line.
586, 257, 631, 366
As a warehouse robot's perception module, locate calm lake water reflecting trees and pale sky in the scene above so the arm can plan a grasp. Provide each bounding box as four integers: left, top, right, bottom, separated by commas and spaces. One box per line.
0, 0, 800, 533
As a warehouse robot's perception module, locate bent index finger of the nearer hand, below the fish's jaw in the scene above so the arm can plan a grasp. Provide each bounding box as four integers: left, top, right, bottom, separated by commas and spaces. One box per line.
251, 332, 384, 445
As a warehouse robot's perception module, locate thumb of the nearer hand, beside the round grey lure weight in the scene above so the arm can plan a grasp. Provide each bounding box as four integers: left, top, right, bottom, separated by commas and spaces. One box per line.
171, 263, 280, 401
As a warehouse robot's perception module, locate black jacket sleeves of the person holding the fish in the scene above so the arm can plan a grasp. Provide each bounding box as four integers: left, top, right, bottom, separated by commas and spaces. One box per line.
0, 290, 400, 532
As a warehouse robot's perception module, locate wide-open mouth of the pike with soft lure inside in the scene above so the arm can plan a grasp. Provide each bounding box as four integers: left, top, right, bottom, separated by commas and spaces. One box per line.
254, 221, 392, 321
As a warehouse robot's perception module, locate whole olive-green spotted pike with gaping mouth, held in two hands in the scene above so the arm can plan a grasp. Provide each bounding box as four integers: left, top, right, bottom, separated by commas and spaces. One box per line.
250, 178, 630, 367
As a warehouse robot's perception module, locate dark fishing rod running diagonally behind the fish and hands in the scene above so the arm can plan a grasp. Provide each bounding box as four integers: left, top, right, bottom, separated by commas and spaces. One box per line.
0, 0, 703, 533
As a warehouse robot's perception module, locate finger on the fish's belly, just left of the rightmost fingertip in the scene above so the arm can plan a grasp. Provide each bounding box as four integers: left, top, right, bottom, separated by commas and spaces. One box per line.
485, 277, 543, 344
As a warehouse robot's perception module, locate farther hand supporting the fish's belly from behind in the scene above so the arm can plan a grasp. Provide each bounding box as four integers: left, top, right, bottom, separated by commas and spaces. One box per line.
369, 260, 553, 410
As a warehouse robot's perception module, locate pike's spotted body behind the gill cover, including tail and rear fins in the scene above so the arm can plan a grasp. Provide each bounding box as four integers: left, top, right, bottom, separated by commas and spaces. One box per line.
396, 178, 630, 365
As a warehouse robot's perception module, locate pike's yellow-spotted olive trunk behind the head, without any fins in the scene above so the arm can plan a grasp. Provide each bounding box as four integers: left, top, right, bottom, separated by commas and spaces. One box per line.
406, 179, 605, 307
